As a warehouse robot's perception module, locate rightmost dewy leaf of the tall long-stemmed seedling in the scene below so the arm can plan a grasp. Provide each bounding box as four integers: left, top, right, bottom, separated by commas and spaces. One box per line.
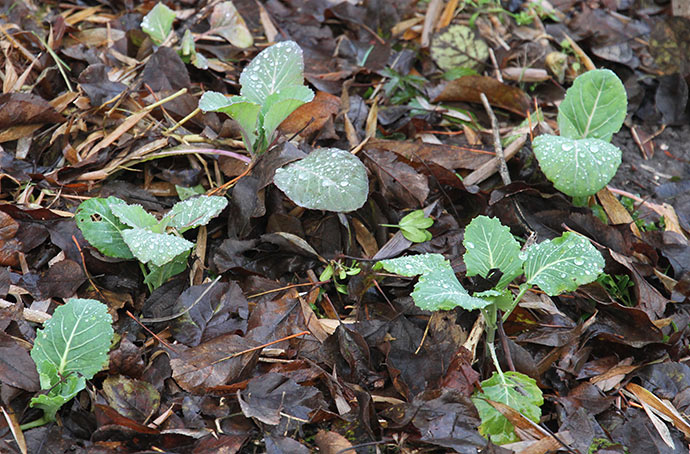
523, 232, 604, 296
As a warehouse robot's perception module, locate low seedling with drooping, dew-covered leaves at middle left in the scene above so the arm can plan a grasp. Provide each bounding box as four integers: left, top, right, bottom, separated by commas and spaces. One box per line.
75, 196, 228, 290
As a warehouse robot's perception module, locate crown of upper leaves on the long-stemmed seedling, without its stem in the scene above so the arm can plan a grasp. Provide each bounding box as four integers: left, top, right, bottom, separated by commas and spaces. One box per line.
378, 216, 604, 311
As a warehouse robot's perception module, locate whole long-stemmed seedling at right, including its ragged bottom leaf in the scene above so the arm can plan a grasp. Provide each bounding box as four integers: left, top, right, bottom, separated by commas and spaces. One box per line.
376, 216, 604, 443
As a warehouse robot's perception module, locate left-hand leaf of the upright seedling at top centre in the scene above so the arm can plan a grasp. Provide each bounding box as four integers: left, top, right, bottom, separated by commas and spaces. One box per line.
199, 91, 261, 152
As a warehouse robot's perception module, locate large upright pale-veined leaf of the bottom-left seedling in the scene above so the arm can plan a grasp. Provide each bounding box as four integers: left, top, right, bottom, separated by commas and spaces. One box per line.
31, 298, 113, 389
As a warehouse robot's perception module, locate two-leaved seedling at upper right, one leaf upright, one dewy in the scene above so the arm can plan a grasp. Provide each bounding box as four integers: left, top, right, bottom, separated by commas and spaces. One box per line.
532, 69, 628, 199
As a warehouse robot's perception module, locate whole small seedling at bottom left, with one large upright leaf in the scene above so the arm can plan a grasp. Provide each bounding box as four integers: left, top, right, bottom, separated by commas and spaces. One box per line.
21, 298, 113, 430
